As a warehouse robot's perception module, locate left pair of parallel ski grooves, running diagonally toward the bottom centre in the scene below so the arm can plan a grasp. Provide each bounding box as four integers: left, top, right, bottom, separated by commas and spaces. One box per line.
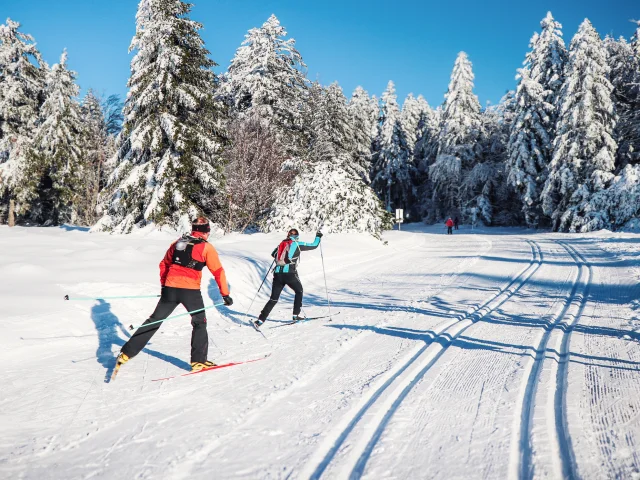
301, 239, 542, 479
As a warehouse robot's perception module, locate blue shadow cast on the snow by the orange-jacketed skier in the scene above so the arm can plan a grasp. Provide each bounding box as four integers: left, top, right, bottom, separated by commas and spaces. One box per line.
91, 300, 191, 383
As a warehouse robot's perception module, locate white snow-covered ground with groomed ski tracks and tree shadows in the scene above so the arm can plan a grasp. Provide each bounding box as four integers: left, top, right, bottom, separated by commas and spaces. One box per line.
0, 227, 640, 479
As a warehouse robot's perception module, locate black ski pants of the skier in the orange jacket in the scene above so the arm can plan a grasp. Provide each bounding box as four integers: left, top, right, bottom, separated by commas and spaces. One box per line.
122, 287, 209, 363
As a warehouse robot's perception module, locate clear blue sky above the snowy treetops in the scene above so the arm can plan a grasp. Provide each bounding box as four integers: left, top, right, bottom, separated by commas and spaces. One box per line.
5, 0, 640, 106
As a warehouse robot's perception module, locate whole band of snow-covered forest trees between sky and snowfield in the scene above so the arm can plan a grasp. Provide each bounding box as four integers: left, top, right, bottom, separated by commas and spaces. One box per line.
0, 0, 640, 236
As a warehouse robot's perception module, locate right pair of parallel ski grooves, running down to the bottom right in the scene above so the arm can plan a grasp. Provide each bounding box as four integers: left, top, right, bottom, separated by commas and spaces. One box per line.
509, 241, 591, 479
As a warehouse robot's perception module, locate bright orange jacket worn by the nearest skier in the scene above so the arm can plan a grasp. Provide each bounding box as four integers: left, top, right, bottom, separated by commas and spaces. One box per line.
160, 232, 229, 297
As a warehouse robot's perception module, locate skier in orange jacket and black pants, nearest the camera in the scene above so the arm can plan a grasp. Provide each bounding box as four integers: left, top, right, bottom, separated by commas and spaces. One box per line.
113, 217, 233, 377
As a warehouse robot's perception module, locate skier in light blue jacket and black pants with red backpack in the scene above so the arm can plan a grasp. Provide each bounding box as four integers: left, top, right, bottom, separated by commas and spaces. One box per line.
255, 228, 322, 327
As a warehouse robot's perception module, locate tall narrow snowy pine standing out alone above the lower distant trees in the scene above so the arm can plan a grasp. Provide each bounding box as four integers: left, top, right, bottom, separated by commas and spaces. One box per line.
429, 52, 481, 221
